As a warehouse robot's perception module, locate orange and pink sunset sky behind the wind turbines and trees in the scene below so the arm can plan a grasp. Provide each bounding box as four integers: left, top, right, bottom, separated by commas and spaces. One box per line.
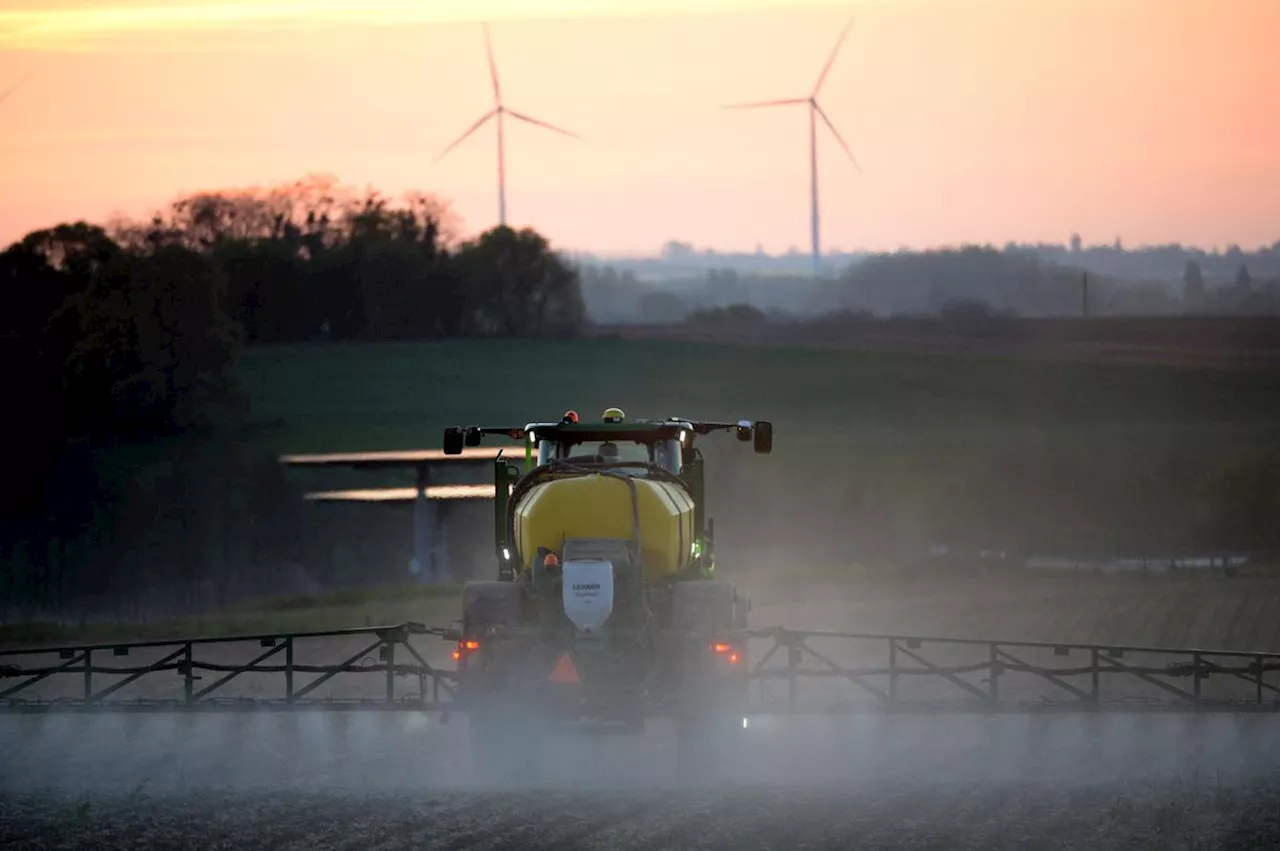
0, 0, 1280, 252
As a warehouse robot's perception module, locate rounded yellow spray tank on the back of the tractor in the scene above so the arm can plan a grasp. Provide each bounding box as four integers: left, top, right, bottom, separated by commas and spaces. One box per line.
511, 472, 696, 581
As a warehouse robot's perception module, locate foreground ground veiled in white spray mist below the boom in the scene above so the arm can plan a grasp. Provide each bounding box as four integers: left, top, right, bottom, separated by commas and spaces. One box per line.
0, 713, 1280, 848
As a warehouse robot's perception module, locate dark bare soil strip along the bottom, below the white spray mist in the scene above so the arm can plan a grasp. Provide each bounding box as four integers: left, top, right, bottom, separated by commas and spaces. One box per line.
0, 783, 1280, 851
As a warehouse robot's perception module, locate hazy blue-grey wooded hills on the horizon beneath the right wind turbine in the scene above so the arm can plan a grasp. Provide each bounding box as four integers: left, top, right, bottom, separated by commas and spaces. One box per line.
573, 246, 1280, 322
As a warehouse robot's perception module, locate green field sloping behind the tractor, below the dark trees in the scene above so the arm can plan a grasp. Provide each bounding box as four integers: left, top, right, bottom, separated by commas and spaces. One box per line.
243, 339, 1280, 562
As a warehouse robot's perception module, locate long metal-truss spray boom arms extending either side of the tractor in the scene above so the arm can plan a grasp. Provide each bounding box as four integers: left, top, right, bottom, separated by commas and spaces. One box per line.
0, 623, 1280, 714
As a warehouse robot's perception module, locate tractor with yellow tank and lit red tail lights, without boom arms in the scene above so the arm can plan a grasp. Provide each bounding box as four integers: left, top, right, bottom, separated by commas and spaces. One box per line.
444, 408, 773, 774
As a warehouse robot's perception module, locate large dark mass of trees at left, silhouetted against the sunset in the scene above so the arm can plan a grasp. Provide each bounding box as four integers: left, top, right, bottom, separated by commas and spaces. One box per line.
0, 177, 585, 624
